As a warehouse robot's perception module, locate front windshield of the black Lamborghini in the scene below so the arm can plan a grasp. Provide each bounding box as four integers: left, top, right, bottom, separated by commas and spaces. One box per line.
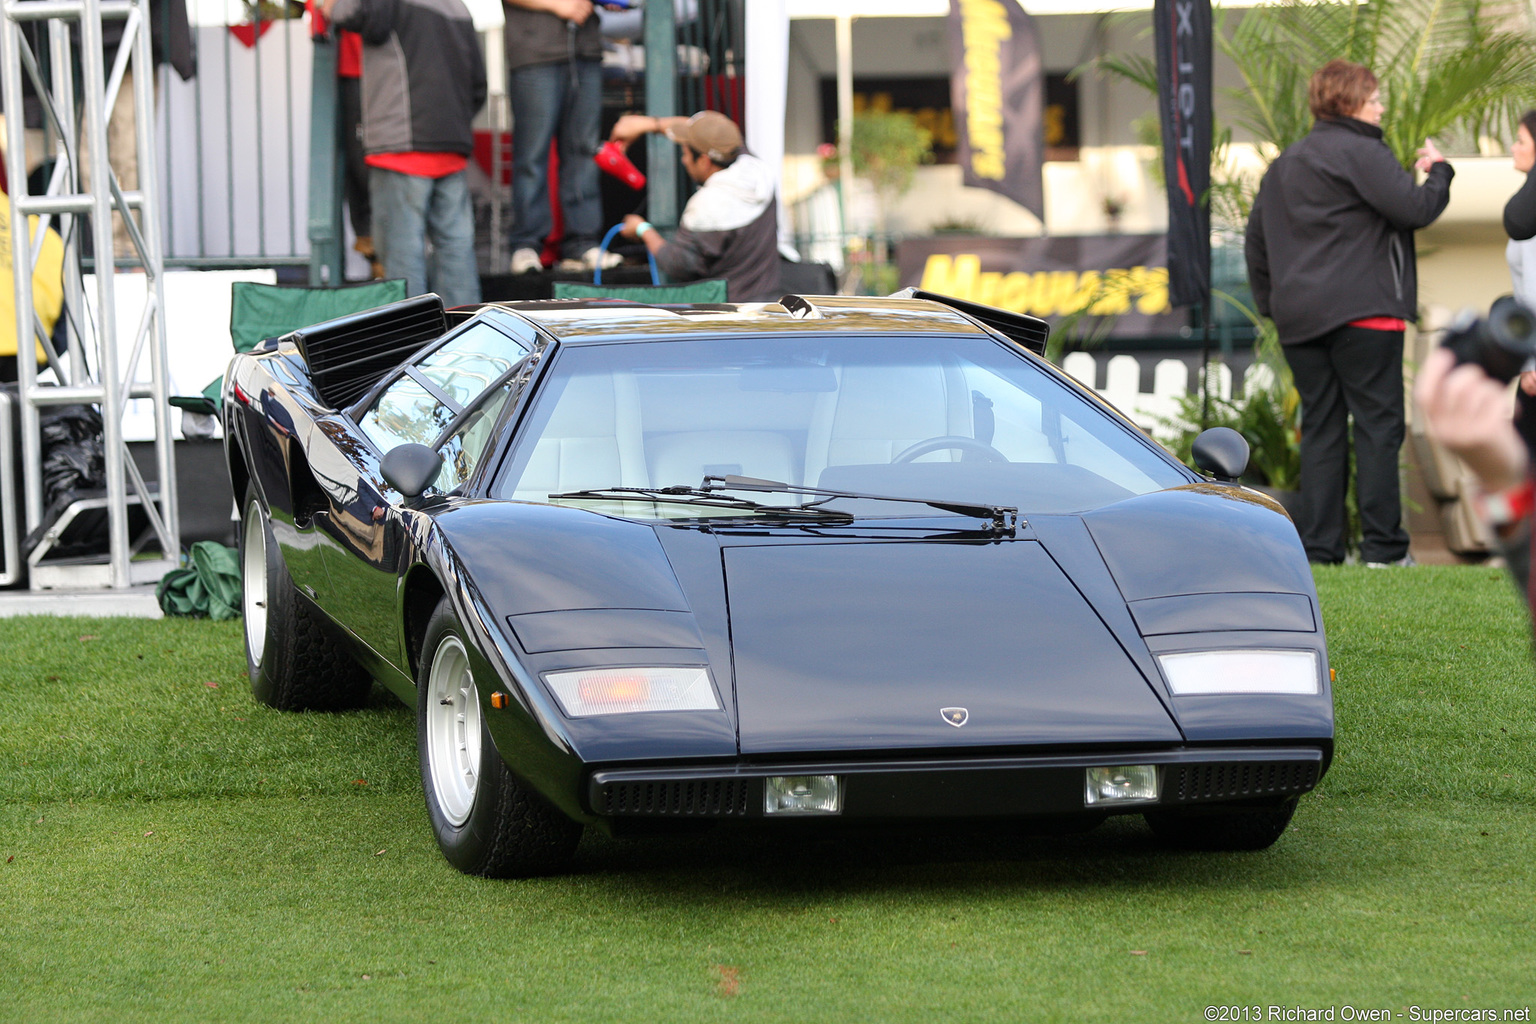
493, 335, 1189, 519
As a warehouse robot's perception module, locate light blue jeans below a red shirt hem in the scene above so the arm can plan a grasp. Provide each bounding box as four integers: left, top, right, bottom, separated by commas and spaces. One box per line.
369, 167, 479, 306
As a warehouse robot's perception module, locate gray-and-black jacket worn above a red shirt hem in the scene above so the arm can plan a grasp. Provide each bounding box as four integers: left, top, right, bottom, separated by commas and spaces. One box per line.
332, 0, 485, 155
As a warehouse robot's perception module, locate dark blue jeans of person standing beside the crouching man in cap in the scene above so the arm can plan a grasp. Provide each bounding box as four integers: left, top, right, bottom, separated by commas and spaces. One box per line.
507, 60, 602, 258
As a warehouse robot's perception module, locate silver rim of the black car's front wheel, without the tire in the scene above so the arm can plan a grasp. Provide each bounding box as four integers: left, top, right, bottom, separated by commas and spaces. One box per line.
427, 634, 481, 827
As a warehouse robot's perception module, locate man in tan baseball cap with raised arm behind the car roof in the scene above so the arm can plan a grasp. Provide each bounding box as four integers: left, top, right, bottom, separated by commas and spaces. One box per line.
611, 111, 779, 302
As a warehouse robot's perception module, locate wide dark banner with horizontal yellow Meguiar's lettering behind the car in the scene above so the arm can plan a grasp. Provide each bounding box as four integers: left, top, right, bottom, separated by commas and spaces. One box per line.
895, 235, 1187, 338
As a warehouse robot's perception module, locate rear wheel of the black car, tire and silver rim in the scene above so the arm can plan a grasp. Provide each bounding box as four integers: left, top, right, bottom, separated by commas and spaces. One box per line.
240, 490, 373, 711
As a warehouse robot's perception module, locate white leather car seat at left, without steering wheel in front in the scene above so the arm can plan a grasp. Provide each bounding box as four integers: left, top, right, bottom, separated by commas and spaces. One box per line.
513, 373, 650, 502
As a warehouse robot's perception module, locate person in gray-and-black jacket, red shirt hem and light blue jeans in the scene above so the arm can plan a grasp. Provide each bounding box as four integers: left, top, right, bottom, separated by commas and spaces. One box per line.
323, 0, 485, 306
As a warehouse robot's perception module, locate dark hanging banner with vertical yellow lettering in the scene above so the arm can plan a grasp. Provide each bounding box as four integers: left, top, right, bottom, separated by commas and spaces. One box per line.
949, 0, 1046, 220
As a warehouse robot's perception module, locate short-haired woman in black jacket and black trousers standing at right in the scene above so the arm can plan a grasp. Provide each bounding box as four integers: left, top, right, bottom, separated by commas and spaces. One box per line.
1244, 60, 1453, 568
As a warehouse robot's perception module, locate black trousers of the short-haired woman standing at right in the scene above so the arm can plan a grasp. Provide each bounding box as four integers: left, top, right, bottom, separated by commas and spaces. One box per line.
1286, 327, 1409, 563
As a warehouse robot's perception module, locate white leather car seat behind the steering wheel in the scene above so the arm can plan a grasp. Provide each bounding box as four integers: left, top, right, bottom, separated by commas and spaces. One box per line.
805, 364, 972, 487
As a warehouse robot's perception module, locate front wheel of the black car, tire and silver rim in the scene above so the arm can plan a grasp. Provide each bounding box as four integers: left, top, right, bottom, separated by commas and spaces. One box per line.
416, 600, 582, 878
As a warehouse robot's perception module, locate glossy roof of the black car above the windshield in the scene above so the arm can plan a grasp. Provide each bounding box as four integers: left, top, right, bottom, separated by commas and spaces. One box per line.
466, 295, 1007, 344
